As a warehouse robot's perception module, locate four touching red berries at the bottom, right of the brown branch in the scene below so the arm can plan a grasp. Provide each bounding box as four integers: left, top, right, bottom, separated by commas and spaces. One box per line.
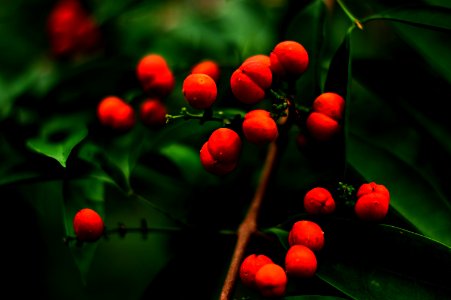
239, 220, 325, 297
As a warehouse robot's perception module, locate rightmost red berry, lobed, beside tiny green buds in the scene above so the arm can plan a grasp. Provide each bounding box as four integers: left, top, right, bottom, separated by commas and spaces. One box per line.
354, 182, 390, 221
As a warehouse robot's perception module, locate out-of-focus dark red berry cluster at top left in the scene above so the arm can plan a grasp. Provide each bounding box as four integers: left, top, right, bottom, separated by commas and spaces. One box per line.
47, 0, 101, 57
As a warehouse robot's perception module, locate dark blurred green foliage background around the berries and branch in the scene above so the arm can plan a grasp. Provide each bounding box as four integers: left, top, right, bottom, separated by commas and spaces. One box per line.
0, 0, 451, 300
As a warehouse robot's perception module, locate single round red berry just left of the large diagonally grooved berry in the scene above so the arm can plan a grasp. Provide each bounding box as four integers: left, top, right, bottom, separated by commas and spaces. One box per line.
182, 73, 218, 109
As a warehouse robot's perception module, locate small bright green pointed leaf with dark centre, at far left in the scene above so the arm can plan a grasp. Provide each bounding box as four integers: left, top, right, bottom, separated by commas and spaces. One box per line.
26, 116, 88, 168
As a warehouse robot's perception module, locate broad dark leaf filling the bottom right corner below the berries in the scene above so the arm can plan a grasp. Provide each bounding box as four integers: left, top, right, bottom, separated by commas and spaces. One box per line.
317, 220, 451, 299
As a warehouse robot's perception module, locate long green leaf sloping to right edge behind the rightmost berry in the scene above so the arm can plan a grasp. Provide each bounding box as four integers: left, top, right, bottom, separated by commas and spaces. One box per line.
347, 135, 451, 245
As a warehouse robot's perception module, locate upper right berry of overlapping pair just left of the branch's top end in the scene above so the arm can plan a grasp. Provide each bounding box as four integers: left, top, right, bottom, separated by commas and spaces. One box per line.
208, 127, 242, 162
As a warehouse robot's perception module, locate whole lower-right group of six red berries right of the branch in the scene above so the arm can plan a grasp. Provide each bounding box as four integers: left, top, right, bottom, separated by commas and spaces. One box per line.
239, 182, 390, 297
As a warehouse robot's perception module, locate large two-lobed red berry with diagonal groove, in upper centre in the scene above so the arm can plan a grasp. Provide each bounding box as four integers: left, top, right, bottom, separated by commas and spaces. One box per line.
230, 61, 272, 104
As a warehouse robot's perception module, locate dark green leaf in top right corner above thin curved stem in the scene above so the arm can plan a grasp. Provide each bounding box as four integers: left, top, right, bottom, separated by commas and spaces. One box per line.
361, 5, 451, 31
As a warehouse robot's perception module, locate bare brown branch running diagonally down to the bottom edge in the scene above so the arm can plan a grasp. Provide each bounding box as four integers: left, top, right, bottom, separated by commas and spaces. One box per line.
220, 141, 278, 300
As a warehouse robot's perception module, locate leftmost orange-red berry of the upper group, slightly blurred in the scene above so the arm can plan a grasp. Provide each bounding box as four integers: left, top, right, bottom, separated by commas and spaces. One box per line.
97, 96, 136, 131
